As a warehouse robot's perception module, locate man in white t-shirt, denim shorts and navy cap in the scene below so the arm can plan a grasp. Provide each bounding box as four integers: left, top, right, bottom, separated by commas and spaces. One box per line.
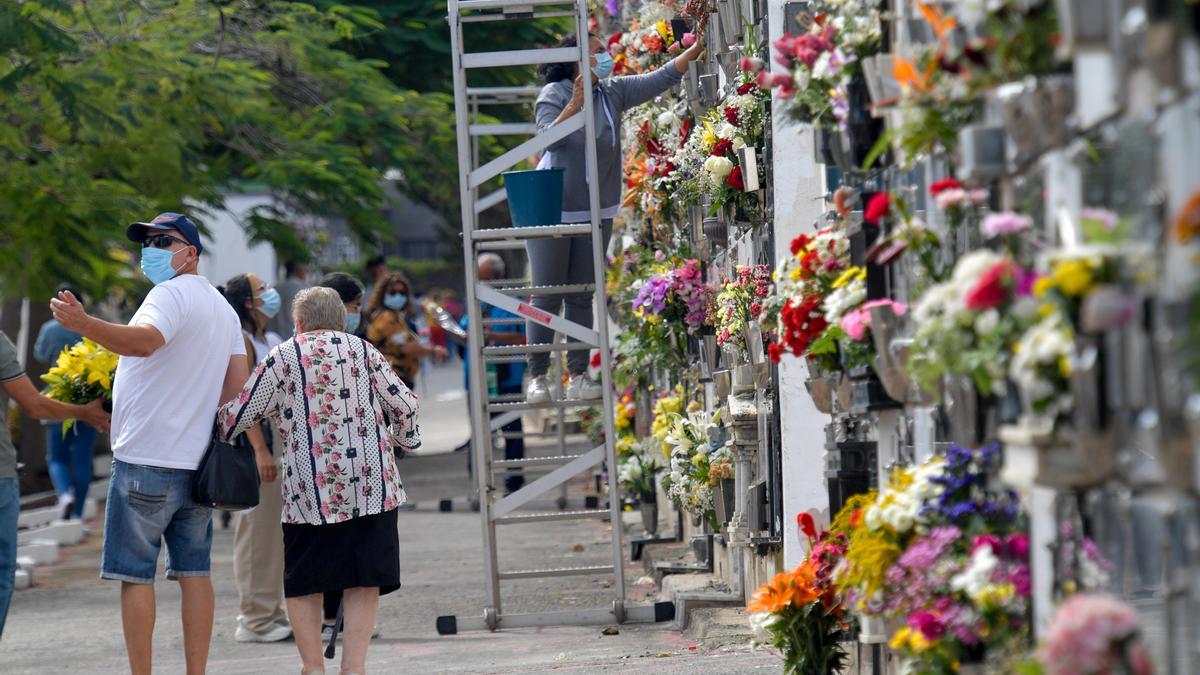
50, 213, 262, 675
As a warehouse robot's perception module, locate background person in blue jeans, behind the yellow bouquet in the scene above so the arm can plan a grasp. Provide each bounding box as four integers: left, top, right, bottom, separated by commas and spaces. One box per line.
34, 283, 96, 520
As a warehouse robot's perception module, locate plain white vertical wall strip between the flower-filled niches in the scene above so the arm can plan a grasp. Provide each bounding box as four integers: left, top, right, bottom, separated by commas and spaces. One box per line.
769, 0, 829, 568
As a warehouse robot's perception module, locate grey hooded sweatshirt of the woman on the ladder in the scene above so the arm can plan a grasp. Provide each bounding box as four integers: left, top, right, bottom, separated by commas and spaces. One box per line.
534, 60, 683, 222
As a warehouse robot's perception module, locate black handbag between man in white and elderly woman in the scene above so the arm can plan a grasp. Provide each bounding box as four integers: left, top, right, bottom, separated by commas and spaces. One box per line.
192, 428, 259, 510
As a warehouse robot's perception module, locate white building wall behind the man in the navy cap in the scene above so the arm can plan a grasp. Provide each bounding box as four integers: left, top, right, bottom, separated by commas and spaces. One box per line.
200, 193, 278, 286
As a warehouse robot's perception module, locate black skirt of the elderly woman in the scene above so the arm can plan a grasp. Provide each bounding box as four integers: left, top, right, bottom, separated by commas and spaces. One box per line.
283, 509, 400, 598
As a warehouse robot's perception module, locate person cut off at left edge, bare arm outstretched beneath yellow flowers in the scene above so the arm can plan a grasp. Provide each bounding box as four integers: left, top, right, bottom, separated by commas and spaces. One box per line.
0, 333, 109, 637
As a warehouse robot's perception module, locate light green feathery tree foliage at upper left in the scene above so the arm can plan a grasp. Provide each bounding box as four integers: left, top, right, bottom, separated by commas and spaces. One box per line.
0, 0, 456, 295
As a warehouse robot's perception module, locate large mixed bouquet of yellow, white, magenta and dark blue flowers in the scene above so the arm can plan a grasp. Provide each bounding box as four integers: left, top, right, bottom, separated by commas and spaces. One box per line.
833, 446, 1031, 673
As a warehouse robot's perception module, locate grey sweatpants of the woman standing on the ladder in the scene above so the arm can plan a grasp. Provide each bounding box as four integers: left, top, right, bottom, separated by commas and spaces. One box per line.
526, 219, 612, 377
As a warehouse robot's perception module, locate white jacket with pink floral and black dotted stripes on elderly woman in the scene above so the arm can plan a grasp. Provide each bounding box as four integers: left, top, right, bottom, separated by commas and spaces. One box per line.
217, 330, 420, 525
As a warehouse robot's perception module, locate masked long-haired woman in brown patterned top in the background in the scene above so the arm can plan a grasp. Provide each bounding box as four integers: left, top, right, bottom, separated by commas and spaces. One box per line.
367, 271, 446, 389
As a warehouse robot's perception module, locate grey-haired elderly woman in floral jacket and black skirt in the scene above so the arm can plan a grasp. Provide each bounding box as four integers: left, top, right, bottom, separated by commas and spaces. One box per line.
218, 288, 420, 674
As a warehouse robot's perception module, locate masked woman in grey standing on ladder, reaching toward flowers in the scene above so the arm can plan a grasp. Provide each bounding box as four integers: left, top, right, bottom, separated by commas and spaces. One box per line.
526, 27, 704, 402
